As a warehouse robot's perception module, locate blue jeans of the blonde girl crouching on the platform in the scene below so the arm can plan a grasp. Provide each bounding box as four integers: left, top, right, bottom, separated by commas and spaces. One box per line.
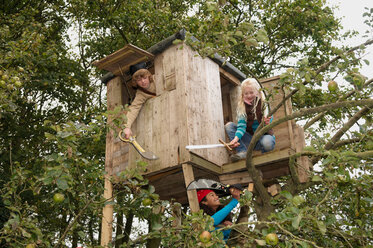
225, 122, 276, 153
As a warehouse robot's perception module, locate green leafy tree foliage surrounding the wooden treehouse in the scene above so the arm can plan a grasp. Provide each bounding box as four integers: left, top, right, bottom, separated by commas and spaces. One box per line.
0, 0, 373, 247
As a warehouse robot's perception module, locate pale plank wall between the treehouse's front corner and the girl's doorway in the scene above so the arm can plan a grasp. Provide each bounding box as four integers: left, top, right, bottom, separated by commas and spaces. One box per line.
183, 46, 228, 165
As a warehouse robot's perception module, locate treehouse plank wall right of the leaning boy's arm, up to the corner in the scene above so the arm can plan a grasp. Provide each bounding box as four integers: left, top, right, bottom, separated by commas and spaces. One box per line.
129, 46, 189, 174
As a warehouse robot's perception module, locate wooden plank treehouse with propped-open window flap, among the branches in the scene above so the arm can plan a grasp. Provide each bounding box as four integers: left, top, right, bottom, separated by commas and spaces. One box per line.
94, 32, 309, 245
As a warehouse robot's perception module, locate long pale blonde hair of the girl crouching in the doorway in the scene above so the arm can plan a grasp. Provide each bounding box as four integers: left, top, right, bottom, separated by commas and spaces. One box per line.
237, 78, 265, 118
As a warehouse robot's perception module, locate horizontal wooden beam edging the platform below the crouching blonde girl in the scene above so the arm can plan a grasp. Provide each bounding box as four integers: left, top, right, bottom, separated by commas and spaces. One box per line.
222, 149, 294, 174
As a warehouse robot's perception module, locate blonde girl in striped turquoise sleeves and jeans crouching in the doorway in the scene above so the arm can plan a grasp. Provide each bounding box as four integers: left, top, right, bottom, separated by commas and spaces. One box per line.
225, 78, 275, 162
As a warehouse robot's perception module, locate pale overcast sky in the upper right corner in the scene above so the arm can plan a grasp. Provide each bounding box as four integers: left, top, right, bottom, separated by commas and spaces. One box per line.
328, 0, 373, 79
